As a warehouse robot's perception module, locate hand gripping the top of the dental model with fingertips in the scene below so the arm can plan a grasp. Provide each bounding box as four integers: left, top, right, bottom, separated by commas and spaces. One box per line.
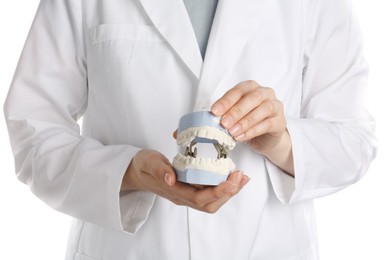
211, 81, 294, 175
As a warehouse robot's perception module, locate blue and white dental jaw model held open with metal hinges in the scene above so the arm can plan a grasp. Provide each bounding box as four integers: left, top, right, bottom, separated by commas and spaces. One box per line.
172, 111, 236, 185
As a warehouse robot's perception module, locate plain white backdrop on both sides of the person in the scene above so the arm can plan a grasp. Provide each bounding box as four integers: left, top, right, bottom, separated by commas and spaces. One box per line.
0, 0, 390, 260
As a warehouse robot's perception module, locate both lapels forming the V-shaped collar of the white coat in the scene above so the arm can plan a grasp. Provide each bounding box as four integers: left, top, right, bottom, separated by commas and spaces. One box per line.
139, 0, 268, 110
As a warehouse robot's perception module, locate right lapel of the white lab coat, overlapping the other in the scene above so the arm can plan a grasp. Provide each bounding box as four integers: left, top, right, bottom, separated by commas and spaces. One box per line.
194, 0, 267, 110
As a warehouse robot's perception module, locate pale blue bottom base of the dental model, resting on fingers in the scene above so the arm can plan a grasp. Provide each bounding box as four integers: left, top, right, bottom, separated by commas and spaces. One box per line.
175, 169, 229, 186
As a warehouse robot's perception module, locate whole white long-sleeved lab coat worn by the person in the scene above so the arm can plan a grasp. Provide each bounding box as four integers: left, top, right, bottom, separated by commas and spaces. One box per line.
4, 0, 375, 260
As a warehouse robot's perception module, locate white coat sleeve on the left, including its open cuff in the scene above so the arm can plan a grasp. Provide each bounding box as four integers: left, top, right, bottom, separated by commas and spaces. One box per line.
4, 0, 155, 233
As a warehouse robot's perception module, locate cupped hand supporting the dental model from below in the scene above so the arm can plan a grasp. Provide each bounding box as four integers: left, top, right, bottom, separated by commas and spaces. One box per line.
122, 150, 249, 213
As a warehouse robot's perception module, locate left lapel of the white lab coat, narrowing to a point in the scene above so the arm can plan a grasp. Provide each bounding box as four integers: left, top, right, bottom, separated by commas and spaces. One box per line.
140, 0, 203, 78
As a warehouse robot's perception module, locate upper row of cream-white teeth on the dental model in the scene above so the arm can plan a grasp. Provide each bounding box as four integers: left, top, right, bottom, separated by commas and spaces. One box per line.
177, 126, 236, 150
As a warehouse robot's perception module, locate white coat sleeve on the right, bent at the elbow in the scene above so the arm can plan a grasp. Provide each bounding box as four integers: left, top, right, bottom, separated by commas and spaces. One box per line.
266, 0, 376, 204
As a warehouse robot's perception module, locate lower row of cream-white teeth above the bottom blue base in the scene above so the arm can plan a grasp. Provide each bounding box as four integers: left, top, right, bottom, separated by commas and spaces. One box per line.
172, 154, 236, 175
